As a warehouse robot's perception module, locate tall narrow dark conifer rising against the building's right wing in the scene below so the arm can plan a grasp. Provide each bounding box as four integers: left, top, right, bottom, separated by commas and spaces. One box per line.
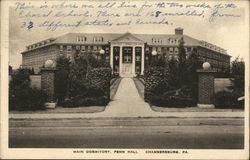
178, 37, 186, 84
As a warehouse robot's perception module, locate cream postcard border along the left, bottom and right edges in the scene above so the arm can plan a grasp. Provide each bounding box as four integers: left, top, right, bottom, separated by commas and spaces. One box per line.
1, 1, 249, 159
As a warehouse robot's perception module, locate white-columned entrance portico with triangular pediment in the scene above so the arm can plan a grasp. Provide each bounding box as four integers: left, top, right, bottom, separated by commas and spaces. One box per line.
110, 33, 144, 77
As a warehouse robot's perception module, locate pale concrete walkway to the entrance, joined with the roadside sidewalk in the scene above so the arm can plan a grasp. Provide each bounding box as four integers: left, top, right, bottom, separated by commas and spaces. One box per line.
9, 78, 244, 119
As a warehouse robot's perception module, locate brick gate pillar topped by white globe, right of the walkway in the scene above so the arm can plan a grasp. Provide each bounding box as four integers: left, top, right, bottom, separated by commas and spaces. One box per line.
197, 62, 216, 108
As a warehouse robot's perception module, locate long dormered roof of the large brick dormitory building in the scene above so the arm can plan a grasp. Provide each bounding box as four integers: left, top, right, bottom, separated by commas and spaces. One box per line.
22, 32, 226, 54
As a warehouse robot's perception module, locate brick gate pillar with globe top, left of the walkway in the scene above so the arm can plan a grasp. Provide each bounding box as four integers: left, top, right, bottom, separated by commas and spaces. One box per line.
41, 61, 56, 108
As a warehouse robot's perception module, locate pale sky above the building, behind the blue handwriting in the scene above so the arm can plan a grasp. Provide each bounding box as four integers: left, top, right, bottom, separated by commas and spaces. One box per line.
9, 1, 249, 68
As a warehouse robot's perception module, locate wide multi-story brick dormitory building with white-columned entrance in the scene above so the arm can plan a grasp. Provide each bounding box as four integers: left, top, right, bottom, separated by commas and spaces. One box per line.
22, 28, 230, 76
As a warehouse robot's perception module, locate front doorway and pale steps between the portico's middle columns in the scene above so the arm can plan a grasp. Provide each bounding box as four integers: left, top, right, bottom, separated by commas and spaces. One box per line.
121, 47, 133, 77
